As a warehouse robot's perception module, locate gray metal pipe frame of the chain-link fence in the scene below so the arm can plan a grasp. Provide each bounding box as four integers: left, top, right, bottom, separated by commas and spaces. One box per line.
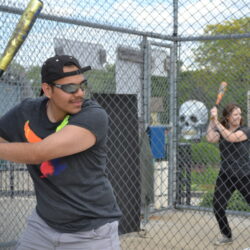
0, 0, 250, 248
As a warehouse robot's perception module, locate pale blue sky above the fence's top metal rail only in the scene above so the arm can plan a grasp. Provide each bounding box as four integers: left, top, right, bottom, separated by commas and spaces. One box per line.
0, 0, 250, 35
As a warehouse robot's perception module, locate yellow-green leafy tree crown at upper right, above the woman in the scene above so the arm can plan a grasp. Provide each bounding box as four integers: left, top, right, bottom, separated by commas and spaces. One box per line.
194, 17, 250, 82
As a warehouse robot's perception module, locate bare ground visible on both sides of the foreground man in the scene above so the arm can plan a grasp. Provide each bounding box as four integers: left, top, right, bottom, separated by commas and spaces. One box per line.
0, 198, 250, 250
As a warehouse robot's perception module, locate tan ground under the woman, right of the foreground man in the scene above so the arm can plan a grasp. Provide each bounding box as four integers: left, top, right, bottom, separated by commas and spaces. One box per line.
121, 210, 250, 250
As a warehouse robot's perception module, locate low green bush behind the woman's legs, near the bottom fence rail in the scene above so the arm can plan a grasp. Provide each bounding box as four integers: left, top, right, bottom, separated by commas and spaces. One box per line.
199, 191, 250, 212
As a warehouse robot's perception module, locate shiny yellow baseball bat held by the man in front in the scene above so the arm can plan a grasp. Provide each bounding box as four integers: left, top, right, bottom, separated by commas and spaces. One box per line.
0, 0, 43, 77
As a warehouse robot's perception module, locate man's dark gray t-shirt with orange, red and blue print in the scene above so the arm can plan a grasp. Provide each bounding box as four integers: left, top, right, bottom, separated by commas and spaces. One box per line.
0, 97, 121, 232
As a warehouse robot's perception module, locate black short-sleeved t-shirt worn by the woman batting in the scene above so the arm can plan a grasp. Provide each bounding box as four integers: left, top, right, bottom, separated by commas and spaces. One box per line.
219, 127, 250, 177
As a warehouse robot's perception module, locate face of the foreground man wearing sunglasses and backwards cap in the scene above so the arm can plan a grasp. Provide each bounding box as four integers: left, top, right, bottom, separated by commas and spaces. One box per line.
50, 65, 85, 114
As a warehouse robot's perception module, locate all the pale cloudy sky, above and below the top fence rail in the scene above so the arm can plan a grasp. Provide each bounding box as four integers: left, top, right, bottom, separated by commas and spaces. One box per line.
0, 0, 250, 68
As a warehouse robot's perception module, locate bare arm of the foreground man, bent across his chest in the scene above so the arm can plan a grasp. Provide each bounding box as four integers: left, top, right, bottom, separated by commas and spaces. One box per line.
0, 125, 96, 164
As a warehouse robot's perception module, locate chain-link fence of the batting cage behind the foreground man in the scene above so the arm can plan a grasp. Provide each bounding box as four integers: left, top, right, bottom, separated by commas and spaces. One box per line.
0, 0, 250, 250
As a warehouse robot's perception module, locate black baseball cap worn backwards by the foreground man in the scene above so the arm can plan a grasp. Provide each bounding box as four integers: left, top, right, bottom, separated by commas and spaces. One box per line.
41, 55, 91, 83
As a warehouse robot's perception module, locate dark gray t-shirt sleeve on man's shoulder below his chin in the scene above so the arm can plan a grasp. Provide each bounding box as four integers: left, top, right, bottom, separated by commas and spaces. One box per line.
68, 107, 108, 142
